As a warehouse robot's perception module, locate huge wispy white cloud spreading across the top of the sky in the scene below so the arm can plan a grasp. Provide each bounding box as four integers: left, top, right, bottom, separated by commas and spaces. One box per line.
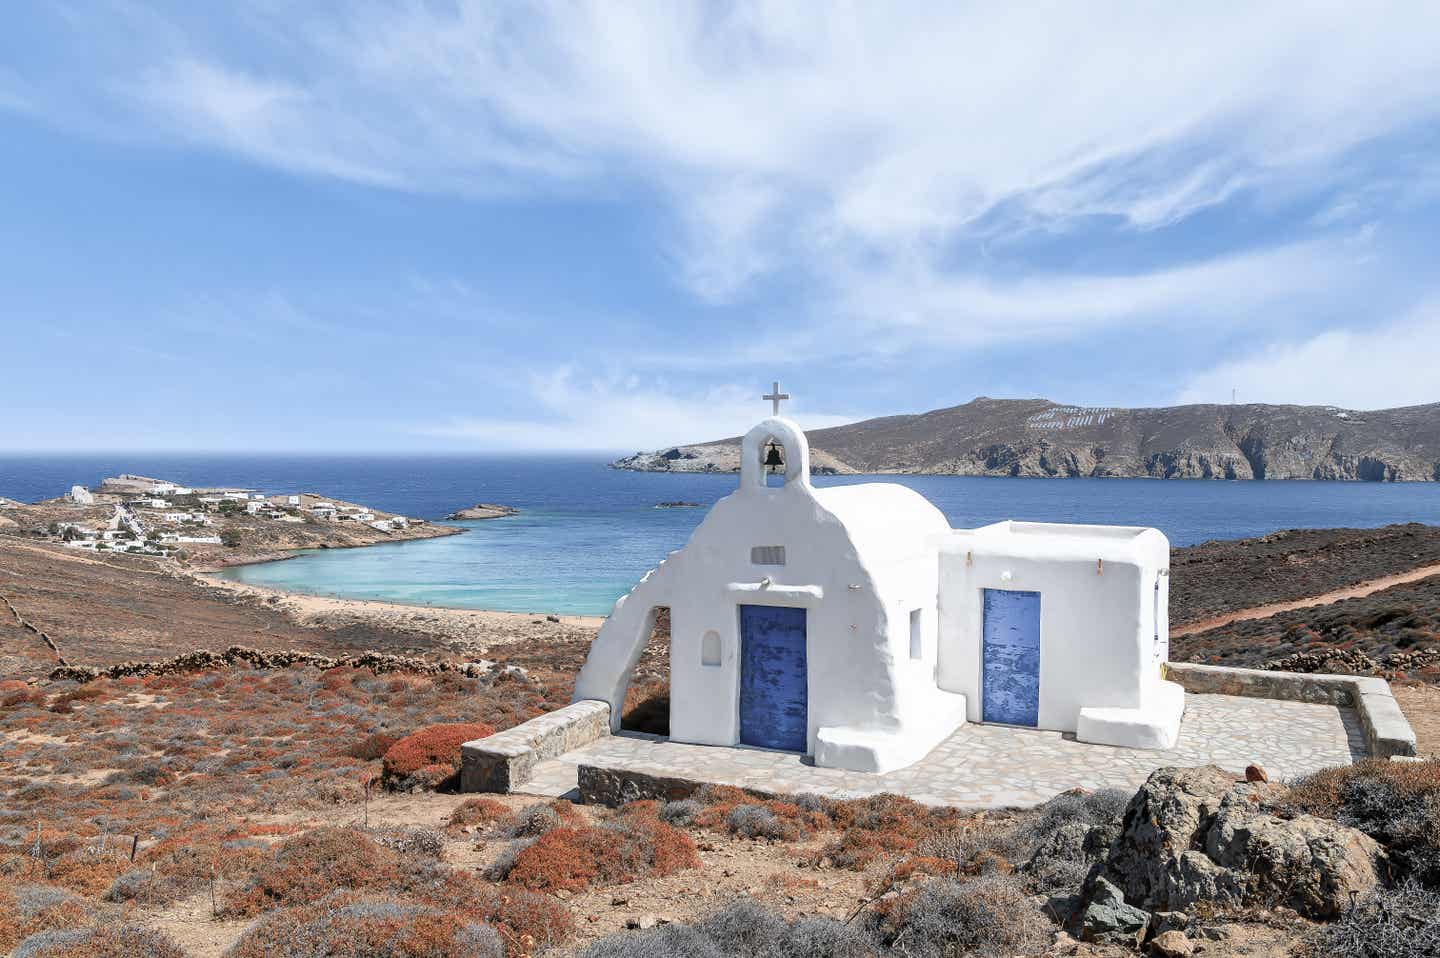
95, 0, 1440, 300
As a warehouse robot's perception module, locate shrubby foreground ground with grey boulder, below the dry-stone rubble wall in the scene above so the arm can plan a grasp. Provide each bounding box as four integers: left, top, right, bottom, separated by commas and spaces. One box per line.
0, 664, 1440, 958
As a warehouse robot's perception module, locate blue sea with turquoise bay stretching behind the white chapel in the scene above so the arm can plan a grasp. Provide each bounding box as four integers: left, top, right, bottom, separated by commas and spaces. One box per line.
0, 455, 1440, 614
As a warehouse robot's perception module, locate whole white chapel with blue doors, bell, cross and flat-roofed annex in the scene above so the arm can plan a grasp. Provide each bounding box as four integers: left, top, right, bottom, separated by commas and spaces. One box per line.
575, 385, 1185, 772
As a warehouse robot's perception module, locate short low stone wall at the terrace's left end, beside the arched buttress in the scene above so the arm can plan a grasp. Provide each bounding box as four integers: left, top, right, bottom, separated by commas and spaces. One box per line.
459, 699, 611, 792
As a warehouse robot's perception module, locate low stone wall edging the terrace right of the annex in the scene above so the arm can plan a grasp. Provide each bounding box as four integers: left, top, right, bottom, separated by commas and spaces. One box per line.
1165, 663, 1416, 758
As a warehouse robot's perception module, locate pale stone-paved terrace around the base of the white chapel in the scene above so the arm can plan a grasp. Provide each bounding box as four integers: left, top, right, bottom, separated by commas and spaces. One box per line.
521, 694, 1365, 808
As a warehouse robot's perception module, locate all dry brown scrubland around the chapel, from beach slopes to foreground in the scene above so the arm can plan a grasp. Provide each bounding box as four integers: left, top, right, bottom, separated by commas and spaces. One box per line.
0, 527, 1440, 958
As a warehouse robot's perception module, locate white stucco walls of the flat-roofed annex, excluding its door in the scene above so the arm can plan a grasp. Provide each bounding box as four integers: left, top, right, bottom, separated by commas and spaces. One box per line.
937, 521, 1182, 746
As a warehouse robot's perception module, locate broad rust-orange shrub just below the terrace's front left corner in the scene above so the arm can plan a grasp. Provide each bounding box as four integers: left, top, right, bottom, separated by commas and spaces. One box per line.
497, 802, 700, 892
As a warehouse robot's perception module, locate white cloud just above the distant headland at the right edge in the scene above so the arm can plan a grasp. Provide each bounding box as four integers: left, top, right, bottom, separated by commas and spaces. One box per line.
1176, 301, 1440, 409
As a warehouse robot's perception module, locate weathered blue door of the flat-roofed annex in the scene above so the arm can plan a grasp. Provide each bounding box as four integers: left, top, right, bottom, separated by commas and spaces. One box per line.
981, 589, 1040, 726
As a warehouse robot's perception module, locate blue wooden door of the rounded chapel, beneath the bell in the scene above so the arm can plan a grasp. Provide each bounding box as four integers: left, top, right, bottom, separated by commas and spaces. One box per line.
740, 605, 809, 752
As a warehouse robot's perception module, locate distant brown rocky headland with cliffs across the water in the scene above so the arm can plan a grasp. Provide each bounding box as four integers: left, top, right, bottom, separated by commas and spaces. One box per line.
612, 398, 1440, 483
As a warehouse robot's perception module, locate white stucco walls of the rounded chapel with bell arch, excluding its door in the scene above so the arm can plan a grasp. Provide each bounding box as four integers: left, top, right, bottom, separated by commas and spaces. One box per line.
576, 419, 965, 771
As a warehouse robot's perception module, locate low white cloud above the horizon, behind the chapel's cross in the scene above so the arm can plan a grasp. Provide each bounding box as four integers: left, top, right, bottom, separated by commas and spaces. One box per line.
419, 366, 864, 451
